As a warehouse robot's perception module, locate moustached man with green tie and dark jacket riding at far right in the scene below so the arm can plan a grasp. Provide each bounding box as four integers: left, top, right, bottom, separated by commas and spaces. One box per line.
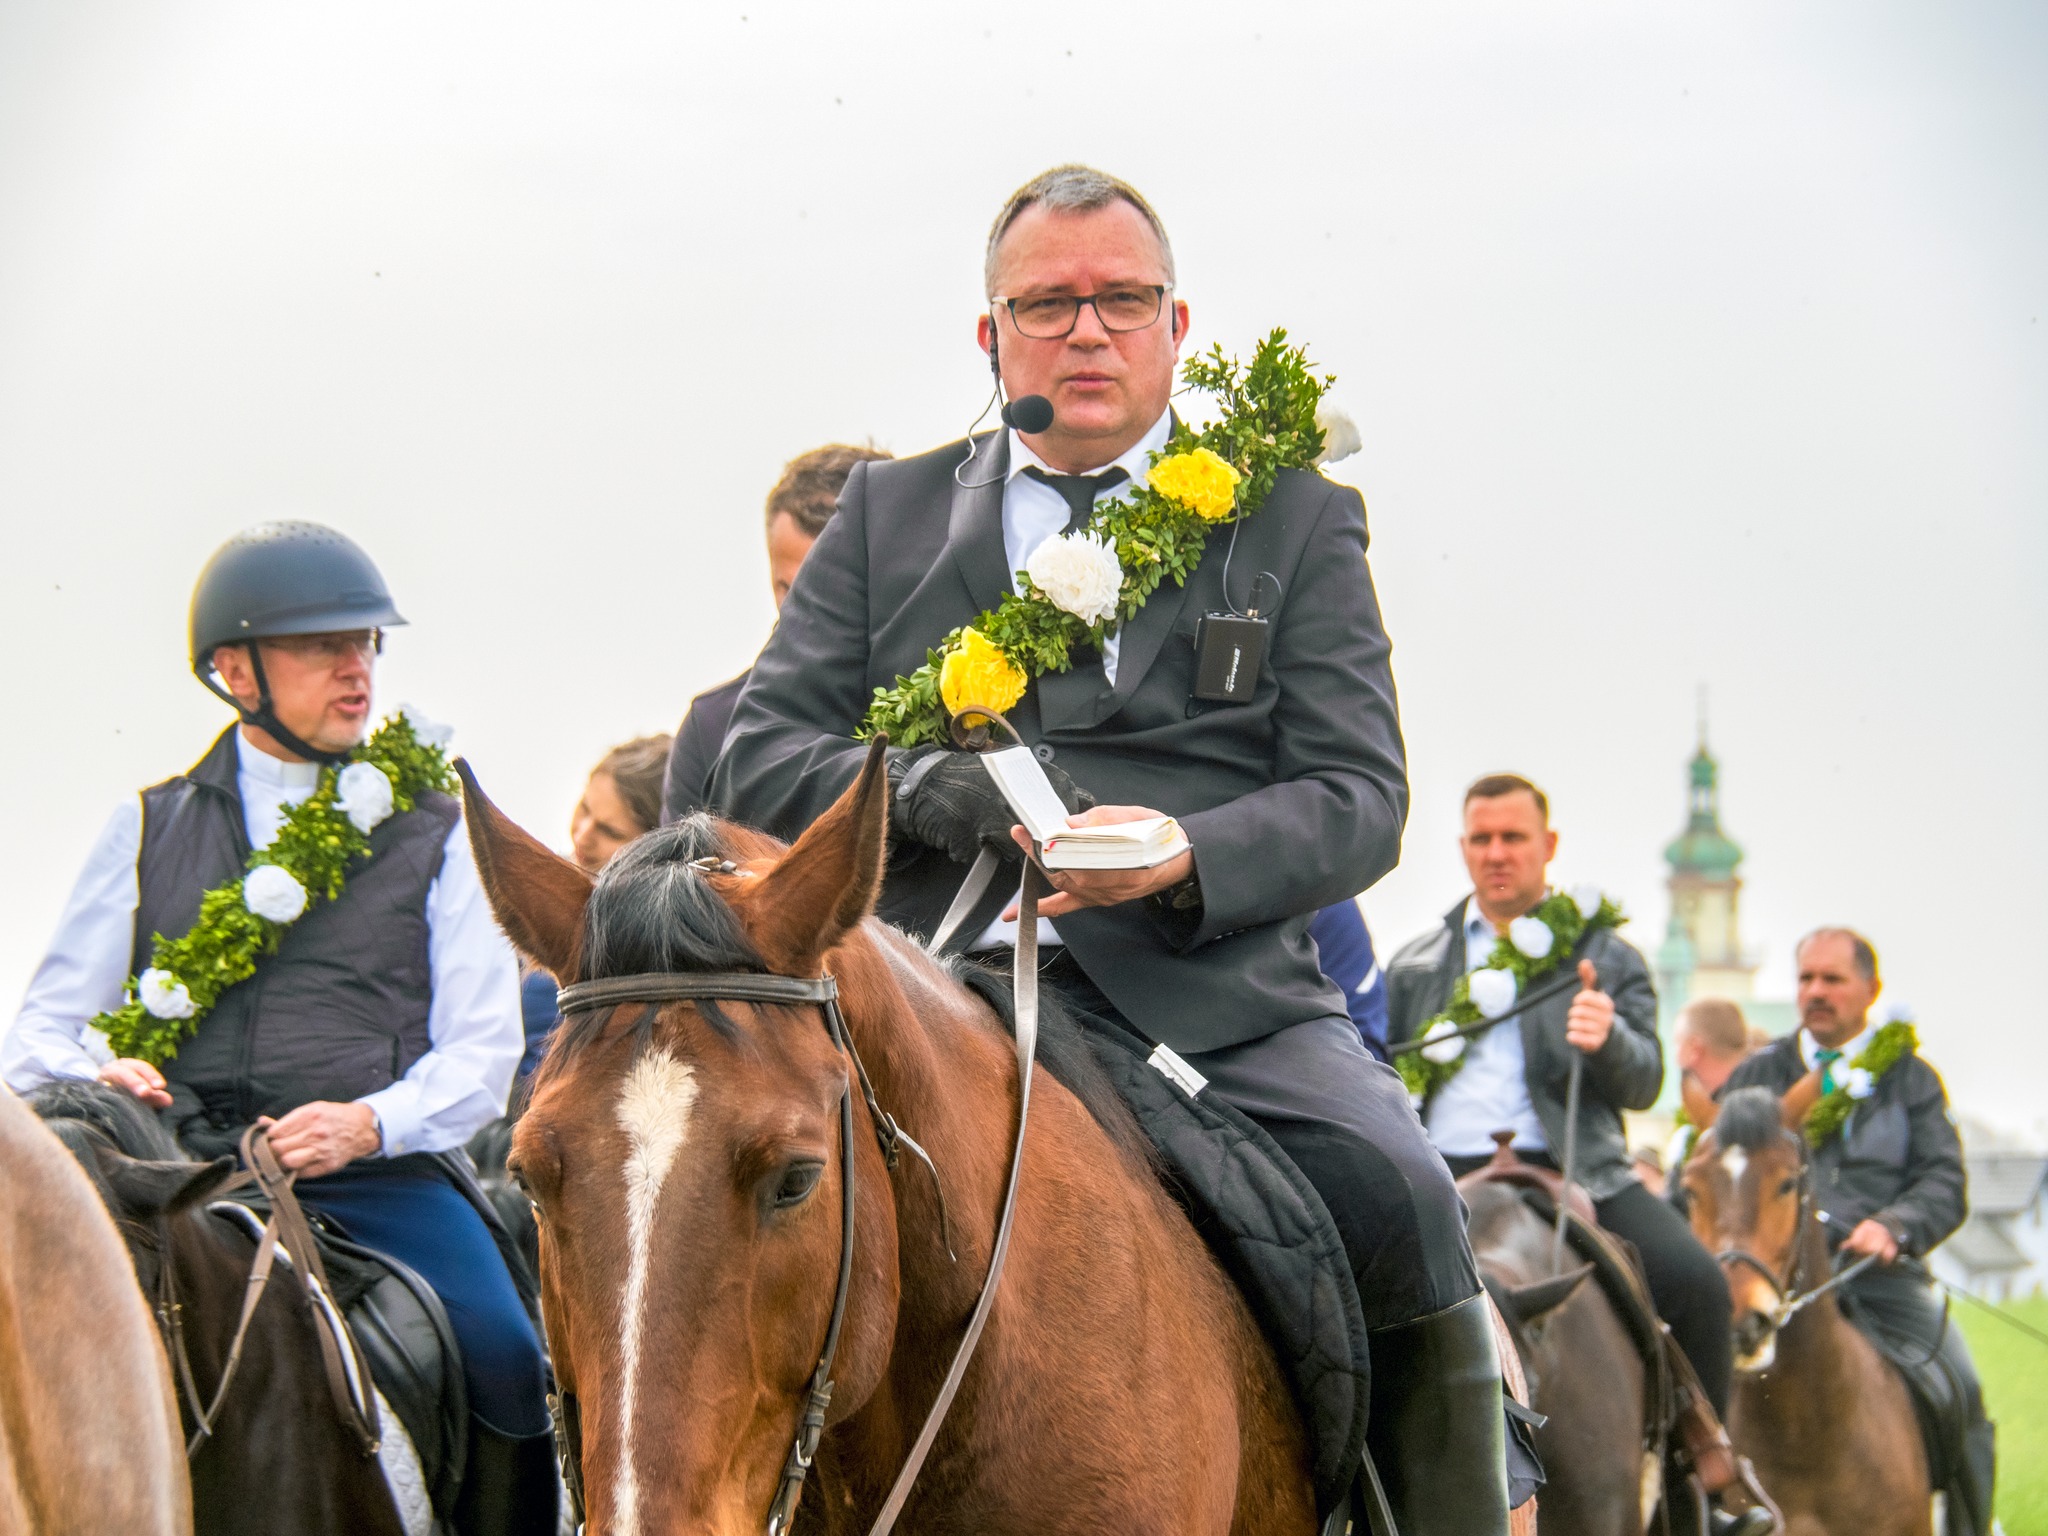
1726, 928, 1997, 1536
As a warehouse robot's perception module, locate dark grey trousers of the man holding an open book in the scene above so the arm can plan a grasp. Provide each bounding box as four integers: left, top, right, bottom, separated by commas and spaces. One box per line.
1040, 950, 1481, 1329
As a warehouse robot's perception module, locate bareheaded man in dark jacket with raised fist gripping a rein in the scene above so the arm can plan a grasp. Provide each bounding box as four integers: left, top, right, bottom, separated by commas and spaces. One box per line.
1386, 774, 1761, 1536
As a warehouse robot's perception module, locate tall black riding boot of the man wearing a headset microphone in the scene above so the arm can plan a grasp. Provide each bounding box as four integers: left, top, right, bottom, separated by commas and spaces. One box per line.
1366, 1292, 1507, 1536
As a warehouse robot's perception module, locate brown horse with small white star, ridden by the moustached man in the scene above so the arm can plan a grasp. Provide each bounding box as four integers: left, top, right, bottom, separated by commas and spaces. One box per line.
1683, 1077, 1933, 1536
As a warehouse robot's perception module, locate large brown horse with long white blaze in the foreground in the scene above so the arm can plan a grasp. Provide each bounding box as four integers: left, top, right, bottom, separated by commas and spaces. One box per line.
465, 752, 1315, 1536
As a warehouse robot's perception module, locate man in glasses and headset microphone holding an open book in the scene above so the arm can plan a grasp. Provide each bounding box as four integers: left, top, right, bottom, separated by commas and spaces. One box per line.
713, 166, 1507, 1536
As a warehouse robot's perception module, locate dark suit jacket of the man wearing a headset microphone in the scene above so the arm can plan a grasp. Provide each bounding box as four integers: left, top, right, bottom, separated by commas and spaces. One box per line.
713, 434, 1407, 1051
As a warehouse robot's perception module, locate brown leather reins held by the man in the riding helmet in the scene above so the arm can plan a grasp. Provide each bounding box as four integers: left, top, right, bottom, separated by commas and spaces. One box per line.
156, 1126, 381, 1460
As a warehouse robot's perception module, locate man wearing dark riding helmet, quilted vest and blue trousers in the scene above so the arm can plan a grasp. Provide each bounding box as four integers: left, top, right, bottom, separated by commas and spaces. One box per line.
0, 522, 557, 1536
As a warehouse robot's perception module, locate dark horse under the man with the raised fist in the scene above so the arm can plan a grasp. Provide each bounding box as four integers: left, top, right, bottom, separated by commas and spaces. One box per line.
1458, 1180, 1659, 1536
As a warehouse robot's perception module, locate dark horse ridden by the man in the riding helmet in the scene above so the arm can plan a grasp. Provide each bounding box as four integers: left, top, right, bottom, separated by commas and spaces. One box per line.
31, 1083, 403, 1536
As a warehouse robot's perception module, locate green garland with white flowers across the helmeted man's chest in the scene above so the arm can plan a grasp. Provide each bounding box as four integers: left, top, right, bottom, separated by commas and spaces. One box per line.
92, 713, 455, 1065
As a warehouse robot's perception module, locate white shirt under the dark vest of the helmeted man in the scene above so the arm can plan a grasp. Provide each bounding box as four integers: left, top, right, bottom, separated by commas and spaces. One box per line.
0, 737, 526, 1157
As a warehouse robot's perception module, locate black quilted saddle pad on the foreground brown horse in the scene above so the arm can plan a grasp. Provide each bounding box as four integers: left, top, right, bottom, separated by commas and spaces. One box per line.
1081, 1018, 1372, 1511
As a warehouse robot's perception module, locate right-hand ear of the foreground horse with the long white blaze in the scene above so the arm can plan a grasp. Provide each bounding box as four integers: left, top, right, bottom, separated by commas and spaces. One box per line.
727, 735, 889, 977
